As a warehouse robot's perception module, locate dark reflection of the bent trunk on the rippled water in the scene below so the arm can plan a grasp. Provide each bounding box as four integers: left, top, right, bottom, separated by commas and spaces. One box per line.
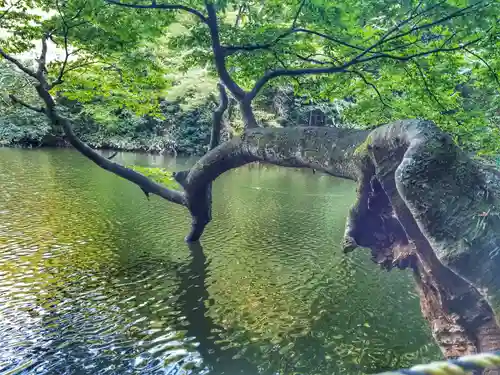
175, 243, 259, 375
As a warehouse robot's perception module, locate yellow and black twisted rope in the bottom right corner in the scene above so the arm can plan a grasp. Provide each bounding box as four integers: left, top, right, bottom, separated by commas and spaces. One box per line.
379, 352, 500, 375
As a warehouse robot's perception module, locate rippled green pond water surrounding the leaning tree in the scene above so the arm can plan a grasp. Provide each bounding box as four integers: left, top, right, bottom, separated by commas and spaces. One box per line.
0, 149, 440, 375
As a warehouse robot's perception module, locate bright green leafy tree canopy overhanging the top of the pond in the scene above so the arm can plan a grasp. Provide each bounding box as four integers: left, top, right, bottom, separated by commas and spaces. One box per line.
0, 0, 500, 153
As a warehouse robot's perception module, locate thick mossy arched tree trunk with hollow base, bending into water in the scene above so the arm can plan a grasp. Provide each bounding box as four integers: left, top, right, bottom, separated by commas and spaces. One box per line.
177, 120, 500, 364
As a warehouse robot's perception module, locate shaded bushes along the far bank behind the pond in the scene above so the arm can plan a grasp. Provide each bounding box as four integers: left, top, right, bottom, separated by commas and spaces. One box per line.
0, 63, 347, 155
